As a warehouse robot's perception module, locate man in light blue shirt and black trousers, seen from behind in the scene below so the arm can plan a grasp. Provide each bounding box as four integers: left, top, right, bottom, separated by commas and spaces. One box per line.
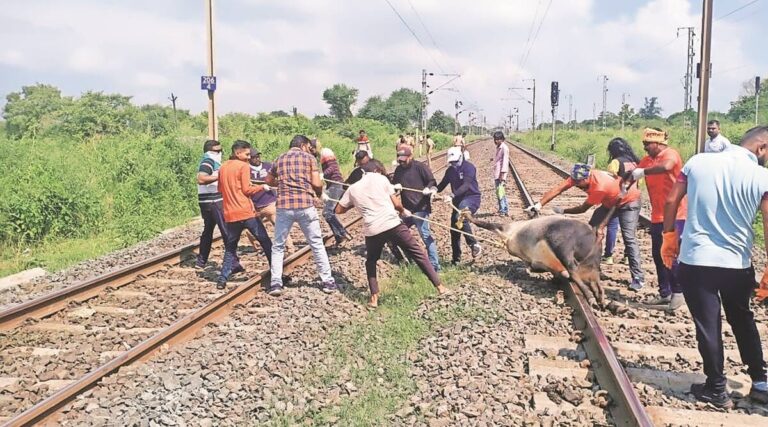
661, 126, 768, 408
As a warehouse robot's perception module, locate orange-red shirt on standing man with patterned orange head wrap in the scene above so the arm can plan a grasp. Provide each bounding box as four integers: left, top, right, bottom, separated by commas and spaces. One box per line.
637, 148, 688, 224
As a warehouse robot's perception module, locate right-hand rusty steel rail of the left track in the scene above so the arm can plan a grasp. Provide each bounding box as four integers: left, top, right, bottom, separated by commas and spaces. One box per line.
3, 140, 480, 427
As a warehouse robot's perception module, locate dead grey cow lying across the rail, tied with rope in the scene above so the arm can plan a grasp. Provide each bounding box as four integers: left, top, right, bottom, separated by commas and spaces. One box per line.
462, 211, 605, 306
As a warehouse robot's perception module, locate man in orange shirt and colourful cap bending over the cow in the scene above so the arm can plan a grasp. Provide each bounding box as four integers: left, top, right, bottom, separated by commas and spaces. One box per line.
526, 163, 645, 291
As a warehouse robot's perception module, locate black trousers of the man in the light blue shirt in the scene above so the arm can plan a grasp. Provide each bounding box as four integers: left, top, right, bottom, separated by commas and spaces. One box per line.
678, 263, 766, 391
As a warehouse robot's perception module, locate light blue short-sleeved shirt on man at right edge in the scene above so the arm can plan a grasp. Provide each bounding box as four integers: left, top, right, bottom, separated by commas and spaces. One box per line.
679, 145, 768, 269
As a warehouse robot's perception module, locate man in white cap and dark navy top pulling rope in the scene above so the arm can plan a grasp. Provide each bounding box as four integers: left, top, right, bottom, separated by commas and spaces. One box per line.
437, 147, 483, 265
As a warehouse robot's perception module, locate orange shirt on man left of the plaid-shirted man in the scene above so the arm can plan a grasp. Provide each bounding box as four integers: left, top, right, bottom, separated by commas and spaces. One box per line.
219, 160, 263, 222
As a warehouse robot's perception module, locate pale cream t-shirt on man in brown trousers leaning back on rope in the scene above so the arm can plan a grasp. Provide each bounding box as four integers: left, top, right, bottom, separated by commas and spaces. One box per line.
339, 173, 402, 237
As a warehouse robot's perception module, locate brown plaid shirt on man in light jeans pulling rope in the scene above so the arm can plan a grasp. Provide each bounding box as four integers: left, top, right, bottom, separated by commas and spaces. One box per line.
269, 148, 318, 209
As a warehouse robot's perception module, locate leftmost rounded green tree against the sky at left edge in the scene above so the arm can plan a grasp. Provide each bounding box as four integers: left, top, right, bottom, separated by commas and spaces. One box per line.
3, 83, 72, 139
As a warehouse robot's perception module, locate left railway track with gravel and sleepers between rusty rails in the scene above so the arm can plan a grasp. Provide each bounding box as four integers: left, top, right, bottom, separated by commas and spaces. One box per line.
0, 145, 462, 426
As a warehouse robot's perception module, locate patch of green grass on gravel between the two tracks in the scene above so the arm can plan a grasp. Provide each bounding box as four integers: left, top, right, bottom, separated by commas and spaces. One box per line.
274, 267, 501, 426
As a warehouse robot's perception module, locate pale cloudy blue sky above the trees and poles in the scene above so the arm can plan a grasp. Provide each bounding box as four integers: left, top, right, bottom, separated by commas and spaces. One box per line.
0, 0, 768, 127
